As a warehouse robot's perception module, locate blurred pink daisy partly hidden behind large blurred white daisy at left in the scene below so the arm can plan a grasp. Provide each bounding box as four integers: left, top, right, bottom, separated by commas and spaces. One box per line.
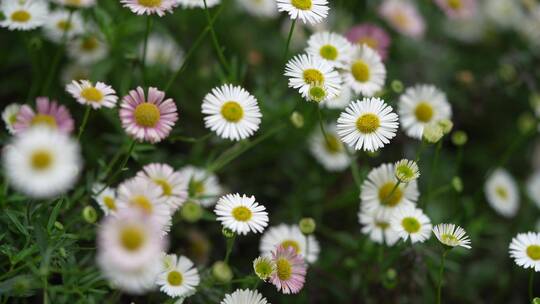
13, 97, 74, 134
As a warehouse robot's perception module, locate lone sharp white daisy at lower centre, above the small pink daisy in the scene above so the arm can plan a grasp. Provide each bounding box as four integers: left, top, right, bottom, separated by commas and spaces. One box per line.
214, 193, 268, 235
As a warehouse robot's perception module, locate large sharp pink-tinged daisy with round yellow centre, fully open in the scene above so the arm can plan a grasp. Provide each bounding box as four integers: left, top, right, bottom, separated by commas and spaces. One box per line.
120, 87, 178, 143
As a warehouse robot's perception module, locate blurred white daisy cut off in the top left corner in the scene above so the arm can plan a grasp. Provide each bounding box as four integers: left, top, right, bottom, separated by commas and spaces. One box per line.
0, 0, 49, 31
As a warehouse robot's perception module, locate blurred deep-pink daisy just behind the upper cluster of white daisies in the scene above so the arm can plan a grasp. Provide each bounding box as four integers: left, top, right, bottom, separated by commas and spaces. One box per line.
345, 23, 391, 59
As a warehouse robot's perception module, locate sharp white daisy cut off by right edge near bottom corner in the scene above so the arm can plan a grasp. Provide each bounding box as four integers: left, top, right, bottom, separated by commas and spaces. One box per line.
510, 232, 540, 272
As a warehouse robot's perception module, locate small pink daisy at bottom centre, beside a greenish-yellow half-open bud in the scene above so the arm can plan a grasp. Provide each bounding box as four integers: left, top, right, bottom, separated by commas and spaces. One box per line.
270, 246, 307, 294
